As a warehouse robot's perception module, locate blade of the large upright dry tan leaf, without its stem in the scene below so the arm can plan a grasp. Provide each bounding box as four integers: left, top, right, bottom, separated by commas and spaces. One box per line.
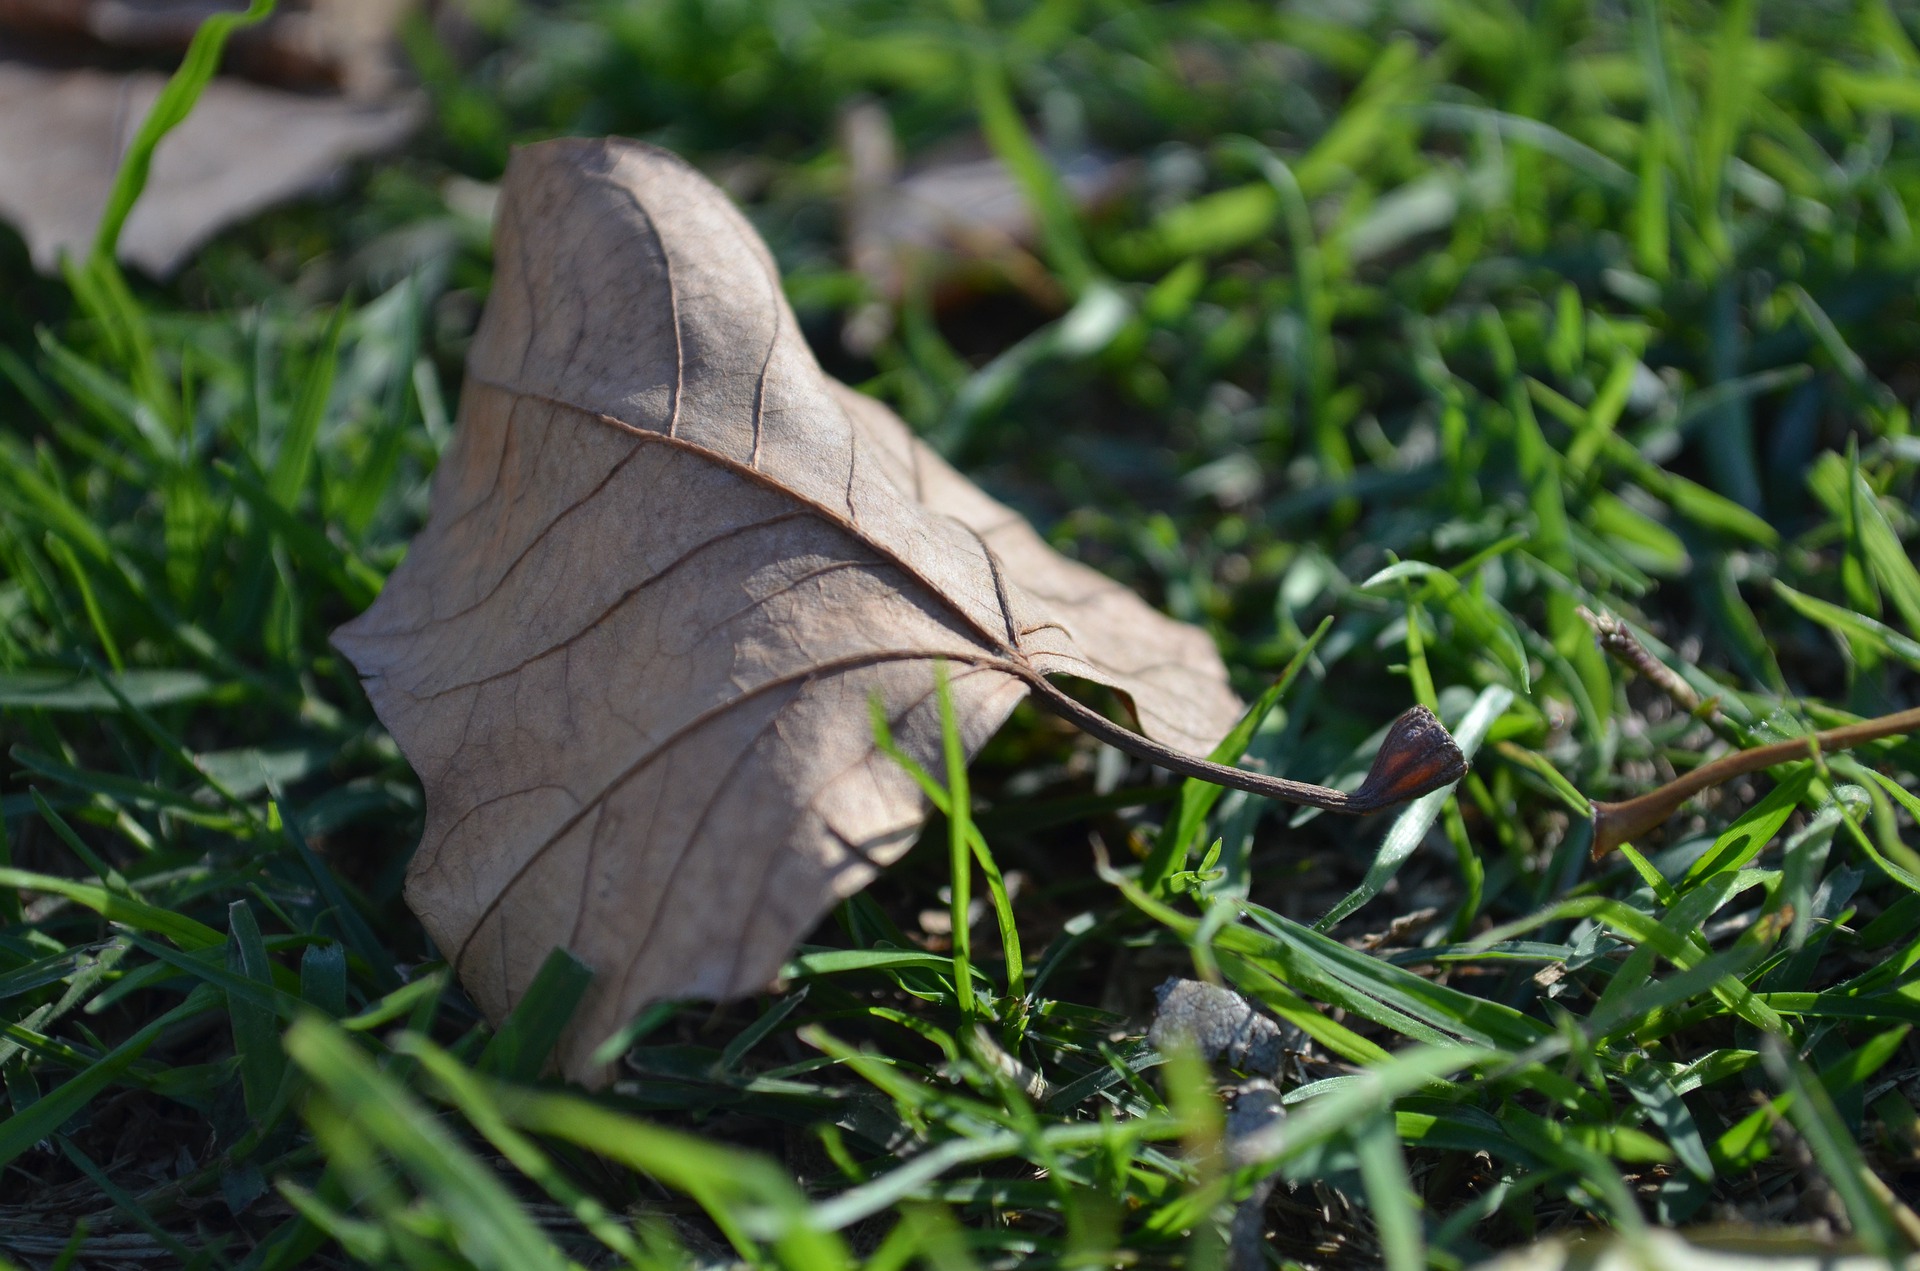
334, 140, 1240, 1081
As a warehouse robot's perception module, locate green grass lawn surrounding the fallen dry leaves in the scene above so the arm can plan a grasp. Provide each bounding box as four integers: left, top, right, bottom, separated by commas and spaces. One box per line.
0, 0, 1920, 1271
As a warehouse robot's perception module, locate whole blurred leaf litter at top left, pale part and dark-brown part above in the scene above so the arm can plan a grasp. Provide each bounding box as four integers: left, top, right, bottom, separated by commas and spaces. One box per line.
0, 0, 424, 278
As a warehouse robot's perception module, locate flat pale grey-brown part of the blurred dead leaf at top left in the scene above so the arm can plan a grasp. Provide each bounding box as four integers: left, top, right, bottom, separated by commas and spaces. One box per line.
0, 61, 422, 278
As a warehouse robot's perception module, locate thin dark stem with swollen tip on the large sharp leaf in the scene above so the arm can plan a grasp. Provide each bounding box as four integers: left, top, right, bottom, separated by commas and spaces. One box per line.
1029, 676, 1467, 816
